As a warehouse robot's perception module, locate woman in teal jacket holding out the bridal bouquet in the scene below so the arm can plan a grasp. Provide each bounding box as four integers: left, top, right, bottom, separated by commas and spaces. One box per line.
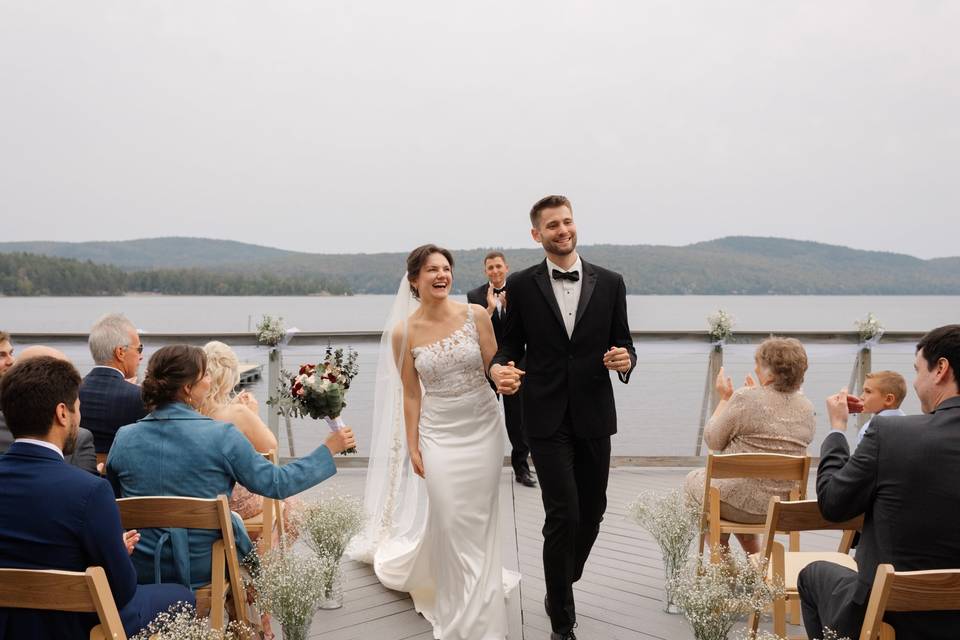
107, 345, 355, 589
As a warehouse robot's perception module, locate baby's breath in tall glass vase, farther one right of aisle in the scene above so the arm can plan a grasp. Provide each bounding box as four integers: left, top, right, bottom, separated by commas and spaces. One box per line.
627, 490, 701, 613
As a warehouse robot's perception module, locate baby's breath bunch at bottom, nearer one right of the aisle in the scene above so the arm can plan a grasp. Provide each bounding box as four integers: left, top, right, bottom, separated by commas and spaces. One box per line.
673, 550, 783, 640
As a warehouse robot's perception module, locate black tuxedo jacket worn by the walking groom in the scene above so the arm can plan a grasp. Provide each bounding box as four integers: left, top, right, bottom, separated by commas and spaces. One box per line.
492, 259, 637, 438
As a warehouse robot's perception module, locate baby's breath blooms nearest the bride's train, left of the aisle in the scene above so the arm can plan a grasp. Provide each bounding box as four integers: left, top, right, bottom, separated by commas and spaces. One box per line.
294, 493, 366, 562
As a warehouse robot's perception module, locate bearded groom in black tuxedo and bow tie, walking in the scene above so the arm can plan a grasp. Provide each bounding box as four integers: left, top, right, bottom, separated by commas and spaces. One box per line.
489, 196, 637, 640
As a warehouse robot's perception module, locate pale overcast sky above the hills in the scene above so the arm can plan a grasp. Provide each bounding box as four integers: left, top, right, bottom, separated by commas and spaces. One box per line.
0, 0, 960, 258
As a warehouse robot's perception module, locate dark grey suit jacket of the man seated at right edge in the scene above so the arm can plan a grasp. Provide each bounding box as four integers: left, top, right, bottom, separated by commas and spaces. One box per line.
817, 397, 960, 608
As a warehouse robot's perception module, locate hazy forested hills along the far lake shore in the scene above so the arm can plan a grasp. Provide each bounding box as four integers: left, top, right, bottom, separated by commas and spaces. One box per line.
0, 236, 960, 295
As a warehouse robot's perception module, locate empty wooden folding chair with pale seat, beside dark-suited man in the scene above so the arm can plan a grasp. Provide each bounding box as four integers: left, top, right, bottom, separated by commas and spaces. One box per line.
752, 496, 863, 638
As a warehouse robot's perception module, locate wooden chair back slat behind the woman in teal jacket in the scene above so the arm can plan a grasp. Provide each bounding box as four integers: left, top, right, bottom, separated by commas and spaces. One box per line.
117, 496, 223, 529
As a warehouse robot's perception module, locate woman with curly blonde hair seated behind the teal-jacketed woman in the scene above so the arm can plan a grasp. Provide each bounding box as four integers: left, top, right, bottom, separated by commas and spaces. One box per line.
199, 340, 291, 540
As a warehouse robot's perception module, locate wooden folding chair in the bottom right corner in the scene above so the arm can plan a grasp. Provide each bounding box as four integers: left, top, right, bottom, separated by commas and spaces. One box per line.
860, 564, 960, 640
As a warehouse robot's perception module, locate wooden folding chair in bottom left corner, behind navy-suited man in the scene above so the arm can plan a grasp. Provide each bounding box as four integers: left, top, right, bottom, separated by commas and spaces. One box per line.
0, 567, 127, 640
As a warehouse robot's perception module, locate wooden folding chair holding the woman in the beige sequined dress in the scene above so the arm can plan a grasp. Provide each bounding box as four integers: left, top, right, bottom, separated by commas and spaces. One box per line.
700, 453, 810, 562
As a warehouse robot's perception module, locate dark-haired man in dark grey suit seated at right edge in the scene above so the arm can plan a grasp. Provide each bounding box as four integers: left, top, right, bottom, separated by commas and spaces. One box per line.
797, 324, 960, 640
